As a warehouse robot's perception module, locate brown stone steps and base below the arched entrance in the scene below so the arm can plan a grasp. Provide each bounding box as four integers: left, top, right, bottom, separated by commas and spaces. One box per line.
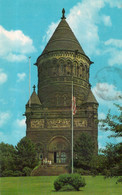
31, 165, 69, 176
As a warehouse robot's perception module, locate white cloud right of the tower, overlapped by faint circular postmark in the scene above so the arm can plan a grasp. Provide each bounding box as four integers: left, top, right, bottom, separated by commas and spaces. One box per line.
92, 83, 122, 101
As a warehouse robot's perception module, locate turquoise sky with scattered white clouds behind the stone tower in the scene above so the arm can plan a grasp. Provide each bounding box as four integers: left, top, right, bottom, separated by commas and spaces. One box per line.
0, 0, 122, 148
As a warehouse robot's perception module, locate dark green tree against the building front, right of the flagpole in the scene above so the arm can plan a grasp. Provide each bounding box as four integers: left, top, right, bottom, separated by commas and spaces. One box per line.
74, 133, 95, 170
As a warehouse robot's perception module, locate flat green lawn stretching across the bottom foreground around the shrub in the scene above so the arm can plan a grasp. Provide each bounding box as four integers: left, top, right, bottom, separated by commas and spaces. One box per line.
0, 176, 122, 195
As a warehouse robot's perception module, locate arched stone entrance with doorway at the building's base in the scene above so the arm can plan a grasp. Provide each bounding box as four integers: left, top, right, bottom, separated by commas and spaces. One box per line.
48, 136, 70, 164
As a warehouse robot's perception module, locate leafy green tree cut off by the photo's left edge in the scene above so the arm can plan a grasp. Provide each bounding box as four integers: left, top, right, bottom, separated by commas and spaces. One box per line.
0, 142, 16, 176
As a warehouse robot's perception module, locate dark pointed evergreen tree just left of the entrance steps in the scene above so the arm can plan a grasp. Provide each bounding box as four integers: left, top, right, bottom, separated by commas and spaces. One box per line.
15, 137, 37, 172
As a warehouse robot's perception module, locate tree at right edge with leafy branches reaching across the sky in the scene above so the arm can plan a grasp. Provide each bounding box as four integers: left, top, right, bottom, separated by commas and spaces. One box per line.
101, 104, 122, 176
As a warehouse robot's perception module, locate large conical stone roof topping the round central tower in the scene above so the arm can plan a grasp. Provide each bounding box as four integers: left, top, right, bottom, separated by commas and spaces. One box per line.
42, 18, 85, 54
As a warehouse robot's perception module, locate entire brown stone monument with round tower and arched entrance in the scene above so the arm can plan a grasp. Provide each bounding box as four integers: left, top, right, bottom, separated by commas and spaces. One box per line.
25, 10, 98, 171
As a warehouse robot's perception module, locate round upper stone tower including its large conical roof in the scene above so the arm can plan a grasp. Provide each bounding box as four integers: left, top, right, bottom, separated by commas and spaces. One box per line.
36, 11, 91, 108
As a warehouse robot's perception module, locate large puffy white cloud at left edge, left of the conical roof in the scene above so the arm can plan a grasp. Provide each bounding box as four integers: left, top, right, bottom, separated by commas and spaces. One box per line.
0, 26, 35, 61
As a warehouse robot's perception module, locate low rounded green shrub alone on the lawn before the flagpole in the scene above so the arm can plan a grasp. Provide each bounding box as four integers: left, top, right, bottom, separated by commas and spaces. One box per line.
54, 174, 86, 191
